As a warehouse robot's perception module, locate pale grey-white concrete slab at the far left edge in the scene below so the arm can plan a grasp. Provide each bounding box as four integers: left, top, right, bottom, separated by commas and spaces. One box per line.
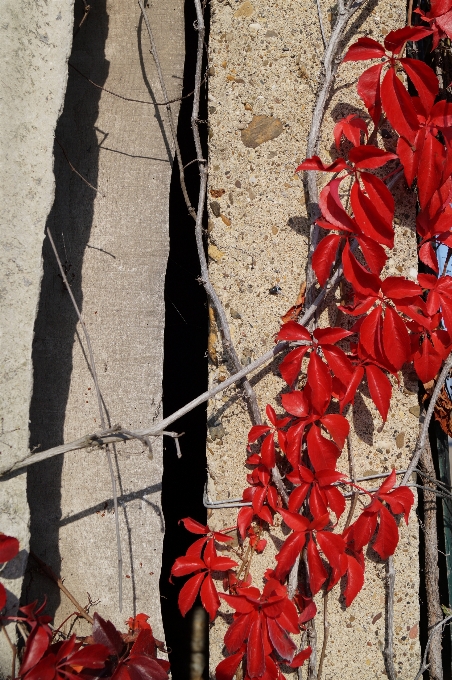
0, 0, 73, 676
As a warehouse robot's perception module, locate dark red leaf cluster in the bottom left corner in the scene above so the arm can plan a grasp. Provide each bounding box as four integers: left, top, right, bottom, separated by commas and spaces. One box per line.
0, 560, 170, 680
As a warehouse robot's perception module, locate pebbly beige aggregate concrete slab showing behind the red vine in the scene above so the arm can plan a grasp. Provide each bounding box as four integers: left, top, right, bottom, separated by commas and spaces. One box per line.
207, 0, 419, 680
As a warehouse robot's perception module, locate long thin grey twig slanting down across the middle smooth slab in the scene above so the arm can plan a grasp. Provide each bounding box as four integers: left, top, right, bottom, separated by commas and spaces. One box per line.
47, 227, 122, 611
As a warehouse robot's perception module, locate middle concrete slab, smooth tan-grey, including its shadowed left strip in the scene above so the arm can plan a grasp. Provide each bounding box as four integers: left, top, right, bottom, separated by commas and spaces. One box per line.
24, 0, 184, 638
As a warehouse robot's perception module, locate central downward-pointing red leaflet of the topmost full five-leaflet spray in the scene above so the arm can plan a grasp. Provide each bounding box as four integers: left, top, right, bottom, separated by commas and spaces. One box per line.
381, 68, 419, 144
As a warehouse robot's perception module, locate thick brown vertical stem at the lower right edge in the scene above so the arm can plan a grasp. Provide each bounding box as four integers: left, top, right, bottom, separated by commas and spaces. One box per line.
420, 436, 443, 680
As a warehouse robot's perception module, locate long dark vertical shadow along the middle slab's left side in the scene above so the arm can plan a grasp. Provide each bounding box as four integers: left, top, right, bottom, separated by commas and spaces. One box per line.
22, 0, 109, 616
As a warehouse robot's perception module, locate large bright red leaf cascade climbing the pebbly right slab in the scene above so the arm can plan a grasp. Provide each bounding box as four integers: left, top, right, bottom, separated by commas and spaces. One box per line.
173, 21, 452, 680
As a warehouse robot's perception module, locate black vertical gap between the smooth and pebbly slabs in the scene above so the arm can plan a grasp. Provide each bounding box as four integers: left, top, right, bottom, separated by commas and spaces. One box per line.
160, 2, 208, 680
